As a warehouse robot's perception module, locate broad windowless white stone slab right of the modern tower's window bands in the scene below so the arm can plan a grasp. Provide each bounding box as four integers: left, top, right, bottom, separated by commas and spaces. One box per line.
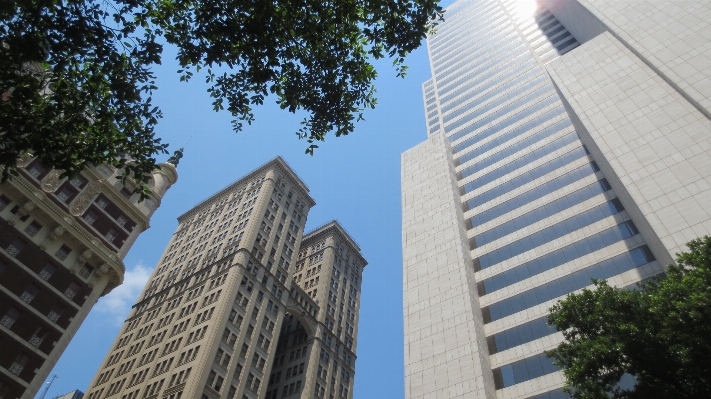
548, 32, 711, 263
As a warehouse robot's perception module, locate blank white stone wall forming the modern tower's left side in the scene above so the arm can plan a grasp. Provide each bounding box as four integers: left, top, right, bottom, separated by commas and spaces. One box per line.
402, 134, 495, 399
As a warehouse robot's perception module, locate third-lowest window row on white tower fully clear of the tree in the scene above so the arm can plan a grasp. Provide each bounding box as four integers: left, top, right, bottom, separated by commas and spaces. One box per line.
479, 198, 624, 269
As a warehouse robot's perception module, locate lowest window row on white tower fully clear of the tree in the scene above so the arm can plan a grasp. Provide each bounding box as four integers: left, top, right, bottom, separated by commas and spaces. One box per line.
482, 245, 654, 324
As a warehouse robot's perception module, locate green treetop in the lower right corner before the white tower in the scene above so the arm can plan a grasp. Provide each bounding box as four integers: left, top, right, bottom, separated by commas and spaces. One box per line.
548, 236, 711, 399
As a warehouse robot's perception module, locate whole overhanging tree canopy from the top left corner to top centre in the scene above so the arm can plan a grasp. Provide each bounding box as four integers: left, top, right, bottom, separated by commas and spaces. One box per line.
0, 0, 442, 194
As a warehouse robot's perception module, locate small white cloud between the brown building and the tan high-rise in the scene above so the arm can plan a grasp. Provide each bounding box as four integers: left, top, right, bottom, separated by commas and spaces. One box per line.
94, 262, 151, 324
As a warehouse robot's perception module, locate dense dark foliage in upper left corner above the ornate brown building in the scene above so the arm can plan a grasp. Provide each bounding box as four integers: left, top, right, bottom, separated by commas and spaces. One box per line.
0, 0, 166, 199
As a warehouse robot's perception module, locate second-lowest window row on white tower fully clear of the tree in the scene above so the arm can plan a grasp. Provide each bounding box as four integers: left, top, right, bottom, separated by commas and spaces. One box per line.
477, 220, 639, 295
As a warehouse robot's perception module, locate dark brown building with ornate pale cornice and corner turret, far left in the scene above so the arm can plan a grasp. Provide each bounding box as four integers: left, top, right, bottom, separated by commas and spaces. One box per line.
0, 156, 178, 398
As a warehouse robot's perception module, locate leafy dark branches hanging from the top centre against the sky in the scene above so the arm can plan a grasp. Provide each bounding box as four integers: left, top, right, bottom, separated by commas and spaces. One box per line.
144, 0, 442, 154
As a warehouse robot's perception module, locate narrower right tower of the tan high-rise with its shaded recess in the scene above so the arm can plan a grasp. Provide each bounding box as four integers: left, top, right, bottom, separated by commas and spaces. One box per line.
265, 221, 367, 399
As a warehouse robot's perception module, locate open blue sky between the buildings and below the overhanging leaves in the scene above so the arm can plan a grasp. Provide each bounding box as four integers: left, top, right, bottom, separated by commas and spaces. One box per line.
40, 25, 440, 399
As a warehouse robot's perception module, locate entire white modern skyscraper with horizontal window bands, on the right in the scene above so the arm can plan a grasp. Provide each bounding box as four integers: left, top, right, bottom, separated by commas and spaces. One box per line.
402, 0, 711, 399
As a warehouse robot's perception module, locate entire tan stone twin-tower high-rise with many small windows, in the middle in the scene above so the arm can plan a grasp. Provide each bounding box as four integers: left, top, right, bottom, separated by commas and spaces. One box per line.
85, 157, 365, 399
